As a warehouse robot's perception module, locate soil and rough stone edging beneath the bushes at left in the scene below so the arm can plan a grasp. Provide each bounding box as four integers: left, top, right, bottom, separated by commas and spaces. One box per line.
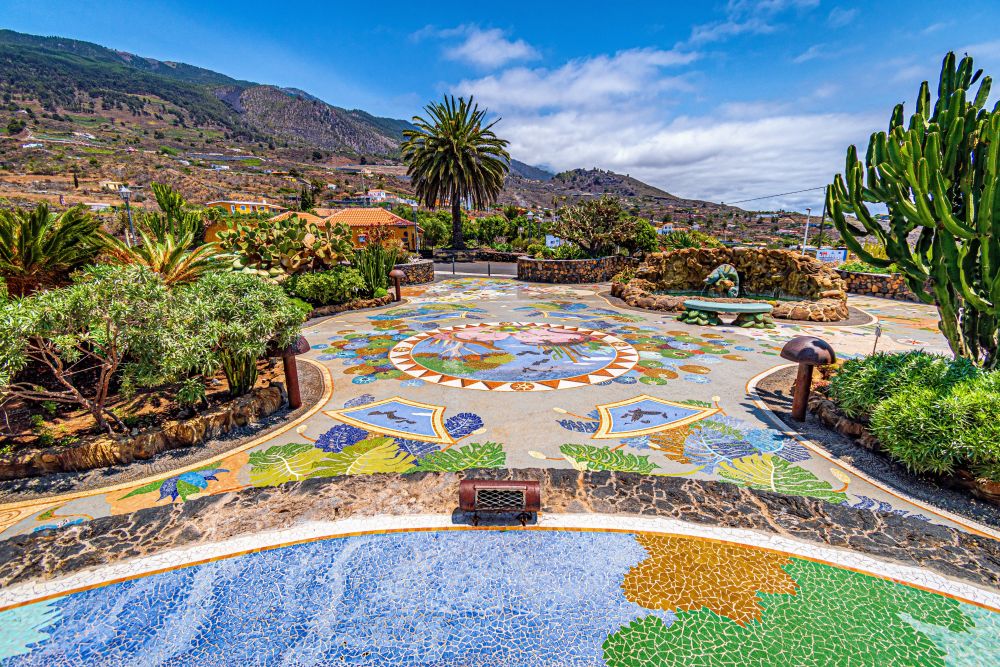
0, 361, 286, 480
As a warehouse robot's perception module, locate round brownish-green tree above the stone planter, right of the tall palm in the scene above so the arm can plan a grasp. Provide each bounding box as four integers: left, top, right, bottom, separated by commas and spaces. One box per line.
552, 195, 636, 257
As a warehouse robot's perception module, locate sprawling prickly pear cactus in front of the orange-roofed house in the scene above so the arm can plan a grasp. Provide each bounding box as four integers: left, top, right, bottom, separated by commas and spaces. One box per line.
219, 216, 353, 280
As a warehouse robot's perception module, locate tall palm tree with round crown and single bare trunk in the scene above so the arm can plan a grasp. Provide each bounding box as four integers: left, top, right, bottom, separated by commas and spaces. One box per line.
402, 96, 510, 250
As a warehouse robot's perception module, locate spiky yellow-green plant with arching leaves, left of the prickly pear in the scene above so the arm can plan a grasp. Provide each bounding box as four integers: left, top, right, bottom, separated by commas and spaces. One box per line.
104, 232, 230, 286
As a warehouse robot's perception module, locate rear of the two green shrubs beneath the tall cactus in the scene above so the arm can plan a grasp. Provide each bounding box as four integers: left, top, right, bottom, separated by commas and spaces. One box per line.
830, 351, 980, 418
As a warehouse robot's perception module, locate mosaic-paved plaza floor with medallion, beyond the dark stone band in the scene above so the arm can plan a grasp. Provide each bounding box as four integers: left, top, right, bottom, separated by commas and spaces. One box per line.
0, 278, 991, 539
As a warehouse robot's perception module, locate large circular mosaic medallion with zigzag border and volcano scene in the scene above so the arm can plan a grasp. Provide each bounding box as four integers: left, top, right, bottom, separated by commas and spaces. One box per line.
389, 322, 639, 391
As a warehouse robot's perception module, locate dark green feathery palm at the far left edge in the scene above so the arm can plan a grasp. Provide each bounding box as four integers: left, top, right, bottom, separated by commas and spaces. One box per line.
0, 204, 101, 296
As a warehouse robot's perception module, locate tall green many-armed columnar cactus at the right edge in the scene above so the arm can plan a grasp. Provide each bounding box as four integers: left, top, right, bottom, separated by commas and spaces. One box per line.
826, 53, 1000, 368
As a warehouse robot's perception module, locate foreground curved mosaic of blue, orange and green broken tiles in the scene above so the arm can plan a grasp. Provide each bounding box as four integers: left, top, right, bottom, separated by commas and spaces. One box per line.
0, 530, 1000, 667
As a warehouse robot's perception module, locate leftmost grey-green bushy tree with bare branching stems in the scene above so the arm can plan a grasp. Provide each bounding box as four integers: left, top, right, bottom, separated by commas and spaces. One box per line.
0, 267, 176, 432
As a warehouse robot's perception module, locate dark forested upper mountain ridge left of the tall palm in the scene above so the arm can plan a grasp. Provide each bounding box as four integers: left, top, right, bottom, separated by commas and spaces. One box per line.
0, 30, 409, 157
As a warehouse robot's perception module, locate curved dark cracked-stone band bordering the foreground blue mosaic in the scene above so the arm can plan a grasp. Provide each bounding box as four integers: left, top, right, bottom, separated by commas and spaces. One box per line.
0, 468, 1000, 588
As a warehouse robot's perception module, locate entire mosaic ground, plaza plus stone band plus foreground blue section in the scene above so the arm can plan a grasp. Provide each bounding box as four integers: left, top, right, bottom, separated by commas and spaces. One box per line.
0, 278, 1000, 667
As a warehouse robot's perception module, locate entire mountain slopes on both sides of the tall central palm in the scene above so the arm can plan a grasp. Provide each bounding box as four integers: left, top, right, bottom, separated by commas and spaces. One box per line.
0, 30, 820, 245
